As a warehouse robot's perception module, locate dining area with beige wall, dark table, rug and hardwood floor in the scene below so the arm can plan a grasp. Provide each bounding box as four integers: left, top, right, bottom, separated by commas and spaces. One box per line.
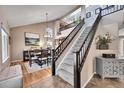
10, 18, 54, 87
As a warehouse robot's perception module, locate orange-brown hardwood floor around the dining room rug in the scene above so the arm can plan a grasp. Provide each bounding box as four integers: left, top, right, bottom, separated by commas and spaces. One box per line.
11, 62, 51, 88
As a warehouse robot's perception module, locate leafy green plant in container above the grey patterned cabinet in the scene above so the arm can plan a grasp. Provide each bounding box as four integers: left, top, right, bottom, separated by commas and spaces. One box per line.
96, 32, 113, 49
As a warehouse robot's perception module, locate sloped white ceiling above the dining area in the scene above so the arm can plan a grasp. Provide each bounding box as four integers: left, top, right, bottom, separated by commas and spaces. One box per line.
0, 5, 78, 27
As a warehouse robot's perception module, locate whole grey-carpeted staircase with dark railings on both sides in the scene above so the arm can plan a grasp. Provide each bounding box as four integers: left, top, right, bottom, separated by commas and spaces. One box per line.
52, 5, 124, 88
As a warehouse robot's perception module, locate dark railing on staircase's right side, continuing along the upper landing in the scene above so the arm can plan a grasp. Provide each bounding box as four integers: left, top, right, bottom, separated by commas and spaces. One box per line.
74, 5, 124, 88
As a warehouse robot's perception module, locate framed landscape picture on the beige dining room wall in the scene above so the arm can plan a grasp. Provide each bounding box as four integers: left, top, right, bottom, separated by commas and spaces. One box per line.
25, 32, 40, 46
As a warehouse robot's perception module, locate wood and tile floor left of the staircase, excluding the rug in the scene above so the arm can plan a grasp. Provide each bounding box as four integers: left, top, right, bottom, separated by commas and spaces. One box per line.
11, 62, 72, 88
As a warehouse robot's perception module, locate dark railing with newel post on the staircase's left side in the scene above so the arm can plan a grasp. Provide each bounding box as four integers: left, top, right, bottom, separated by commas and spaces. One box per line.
52, 19, 85, 75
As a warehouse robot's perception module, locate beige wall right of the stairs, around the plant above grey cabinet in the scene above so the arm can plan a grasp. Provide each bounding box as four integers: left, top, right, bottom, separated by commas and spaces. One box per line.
81, 16, 119, 86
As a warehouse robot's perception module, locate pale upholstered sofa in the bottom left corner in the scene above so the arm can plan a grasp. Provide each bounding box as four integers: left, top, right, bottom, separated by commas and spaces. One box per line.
0, 65, 23, 88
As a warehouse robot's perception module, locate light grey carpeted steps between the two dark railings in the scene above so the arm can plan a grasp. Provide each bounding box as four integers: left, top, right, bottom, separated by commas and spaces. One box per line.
57, 27, 91, 85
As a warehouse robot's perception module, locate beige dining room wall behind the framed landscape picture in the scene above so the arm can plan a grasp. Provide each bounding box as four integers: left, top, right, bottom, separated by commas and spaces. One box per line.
10, 22, 54, 61
